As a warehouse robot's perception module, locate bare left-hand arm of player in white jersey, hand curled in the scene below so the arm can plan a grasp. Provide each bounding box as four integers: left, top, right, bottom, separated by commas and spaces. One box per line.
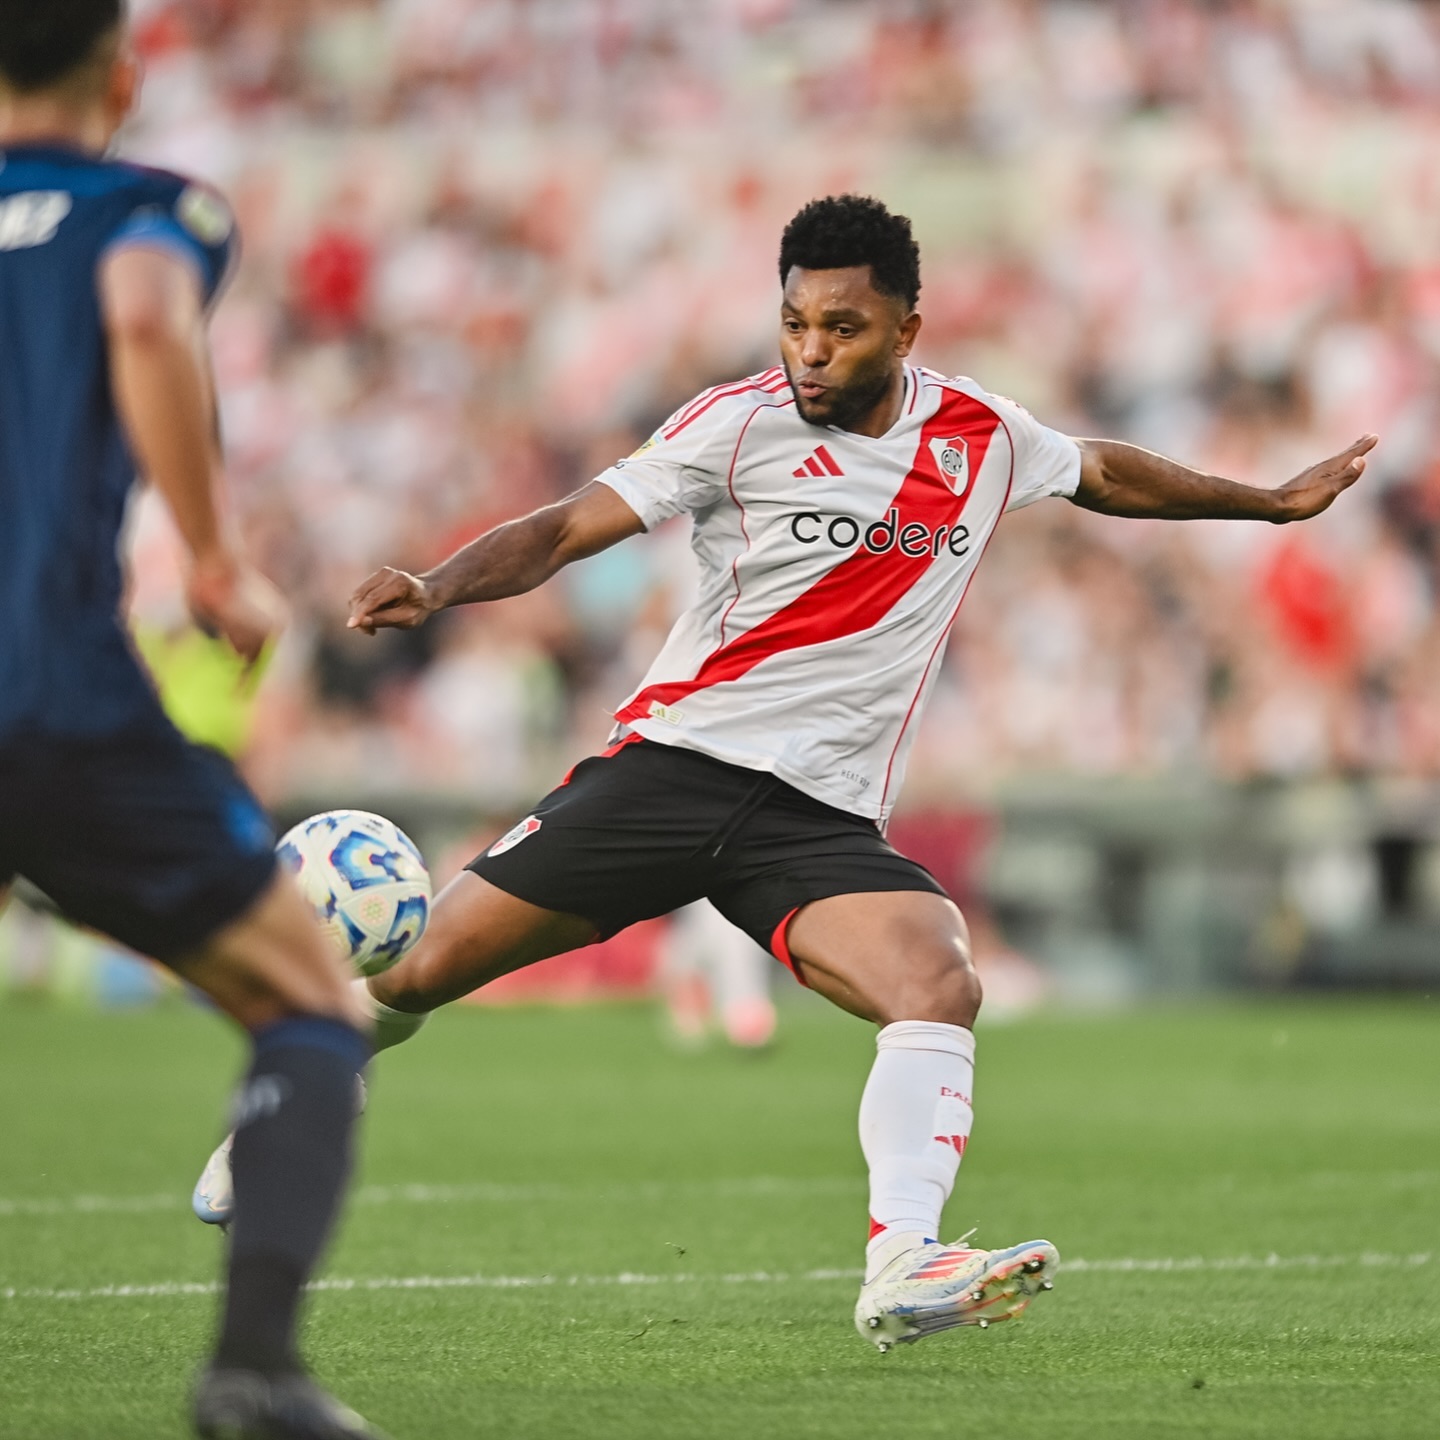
348, 481, 645, 635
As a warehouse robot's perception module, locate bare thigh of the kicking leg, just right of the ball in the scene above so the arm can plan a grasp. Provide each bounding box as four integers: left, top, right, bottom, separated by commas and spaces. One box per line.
370, 870, 598, 1012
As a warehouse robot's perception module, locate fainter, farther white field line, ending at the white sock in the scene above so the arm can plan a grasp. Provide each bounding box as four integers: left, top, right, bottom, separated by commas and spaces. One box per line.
0, 1175, 865, 1220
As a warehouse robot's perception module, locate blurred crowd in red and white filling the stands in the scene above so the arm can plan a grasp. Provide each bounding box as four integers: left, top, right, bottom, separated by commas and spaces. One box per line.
115, 0, 1440, 811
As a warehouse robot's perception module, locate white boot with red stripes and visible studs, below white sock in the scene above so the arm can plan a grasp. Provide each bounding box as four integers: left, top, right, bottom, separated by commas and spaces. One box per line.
855, 1240, 1060, 1354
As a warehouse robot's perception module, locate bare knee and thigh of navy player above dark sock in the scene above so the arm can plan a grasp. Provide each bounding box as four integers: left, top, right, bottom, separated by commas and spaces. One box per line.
170, 870, 360, 1030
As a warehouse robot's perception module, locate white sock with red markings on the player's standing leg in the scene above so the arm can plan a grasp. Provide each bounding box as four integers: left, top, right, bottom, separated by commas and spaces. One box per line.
860, 1020, 975, 1280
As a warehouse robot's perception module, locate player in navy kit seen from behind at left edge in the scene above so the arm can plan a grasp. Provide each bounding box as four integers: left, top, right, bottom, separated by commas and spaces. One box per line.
0, 0, 374, 1440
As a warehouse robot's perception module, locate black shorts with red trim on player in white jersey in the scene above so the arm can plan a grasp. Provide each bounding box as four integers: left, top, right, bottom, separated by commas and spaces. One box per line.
467, 736, 945, 965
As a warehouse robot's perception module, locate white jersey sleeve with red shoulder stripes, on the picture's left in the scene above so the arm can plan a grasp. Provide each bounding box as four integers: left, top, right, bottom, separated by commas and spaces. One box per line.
596, 392, 753, 530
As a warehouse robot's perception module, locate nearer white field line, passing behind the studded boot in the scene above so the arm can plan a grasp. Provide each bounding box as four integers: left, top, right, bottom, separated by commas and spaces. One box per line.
0, 1251, 1434, 1300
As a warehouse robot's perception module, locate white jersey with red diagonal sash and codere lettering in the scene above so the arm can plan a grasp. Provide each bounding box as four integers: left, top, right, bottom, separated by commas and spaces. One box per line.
599, 366, 1080, 824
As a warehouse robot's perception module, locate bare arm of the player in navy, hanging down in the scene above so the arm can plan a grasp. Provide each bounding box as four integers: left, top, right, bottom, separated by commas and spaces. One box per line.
98, 246, 285, 661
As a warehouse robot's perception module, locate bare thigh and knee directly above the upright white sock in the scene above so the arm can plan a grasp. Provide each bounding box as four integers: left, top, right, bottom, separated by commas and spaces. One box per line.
788, 890, 981, 1025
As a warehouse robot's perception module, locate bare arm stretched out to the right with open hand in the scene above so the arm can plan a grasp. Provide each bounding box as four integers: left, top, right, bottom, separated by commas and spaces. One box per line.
1071, 435, 1378, 526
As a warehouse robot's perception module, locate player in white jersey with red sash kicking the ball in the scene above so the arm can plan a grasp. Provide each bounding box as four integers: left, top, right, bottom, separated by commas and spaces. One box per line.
200, 194, 1375, 1349
